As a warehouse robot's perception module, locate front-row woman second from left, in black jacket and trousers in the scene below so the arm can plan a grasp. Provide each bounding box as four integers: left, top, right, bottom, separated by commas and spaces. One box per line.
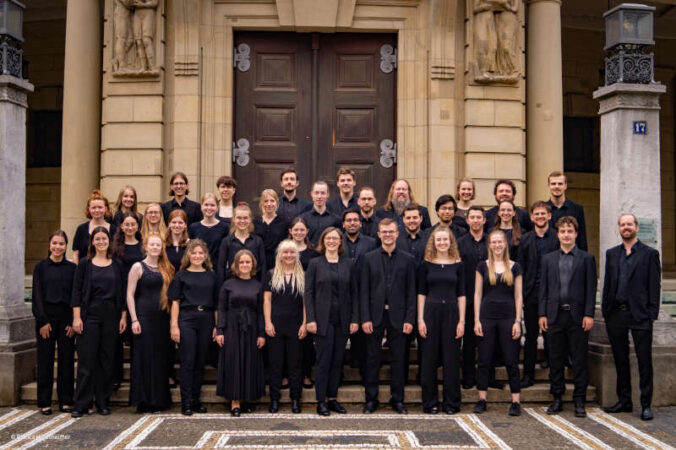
71, 227, 127, 417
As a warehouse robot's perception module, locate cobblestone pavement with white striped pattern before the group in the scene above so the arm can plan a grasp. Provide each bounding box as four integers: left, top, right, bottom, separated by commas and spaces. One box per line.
0, 404, 676, 449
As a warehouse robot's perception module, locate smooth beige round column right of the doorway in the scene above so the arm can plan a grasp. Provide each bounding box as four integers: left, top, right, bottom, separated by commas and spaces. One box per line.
526, 0, 563, 205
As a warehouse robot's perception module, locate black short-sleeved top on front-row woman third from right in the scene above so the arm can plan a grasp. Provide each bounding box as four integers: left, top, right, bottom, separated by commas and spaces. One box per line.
476, 261, 521, 320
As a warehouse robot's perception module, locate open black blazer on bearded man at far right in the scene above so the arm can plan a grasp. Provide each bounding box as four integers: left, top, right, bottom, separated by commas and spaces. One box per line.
601, 241, 661, 322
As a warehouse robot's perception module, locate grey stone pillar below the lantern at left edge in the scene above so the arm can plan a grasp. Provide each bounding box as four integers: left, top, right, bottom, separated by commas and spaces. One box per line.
0, 75, 36, 406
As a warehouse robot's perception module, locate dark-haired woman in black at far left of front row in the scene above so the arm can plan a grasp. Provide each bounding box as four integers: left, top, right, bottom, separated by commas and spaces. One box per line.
32, 230, 77, 415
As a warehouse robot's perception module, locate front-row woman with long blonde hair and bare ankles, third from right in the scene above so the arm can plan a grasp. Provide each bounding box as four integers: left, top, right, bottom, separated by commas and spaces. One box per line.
474, 230, 523, 416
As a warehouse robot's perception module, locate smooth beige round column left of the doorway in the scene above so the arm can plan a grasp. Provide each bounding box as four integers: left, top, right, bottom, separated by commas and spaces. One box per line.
61, 0, 102, 246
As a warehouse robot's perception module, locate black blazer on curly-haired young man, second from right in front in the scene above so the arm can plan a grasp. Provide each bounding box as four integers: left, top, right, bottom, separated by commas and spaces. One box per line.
538, 248, 597, 324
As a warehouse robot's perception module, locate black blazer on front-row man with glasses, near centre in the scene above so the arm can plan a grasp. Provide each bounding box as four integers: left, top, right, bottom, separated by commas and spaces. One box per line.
360, 247, 417, 328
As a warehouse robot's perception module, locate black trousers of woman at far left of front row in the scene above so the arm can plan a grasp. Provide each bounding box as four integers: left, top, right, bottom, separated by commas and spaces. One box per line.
35, 303, 75, 408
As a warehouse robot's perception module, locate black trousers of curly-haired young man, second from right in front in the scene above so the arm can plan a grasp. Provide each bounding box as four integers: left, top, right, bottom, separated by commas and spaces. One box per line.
547, 310, 589, 401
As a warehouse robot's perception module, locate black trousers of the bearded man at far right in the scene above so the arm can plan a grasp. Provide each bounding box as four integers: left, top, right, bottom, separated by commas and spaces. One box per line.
606, 309, 653, 407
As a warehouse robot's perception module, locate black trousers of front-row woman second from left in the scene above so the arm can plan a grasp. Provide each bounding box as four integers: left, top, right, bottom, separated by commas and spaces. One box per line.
73, 302, 120, 411
